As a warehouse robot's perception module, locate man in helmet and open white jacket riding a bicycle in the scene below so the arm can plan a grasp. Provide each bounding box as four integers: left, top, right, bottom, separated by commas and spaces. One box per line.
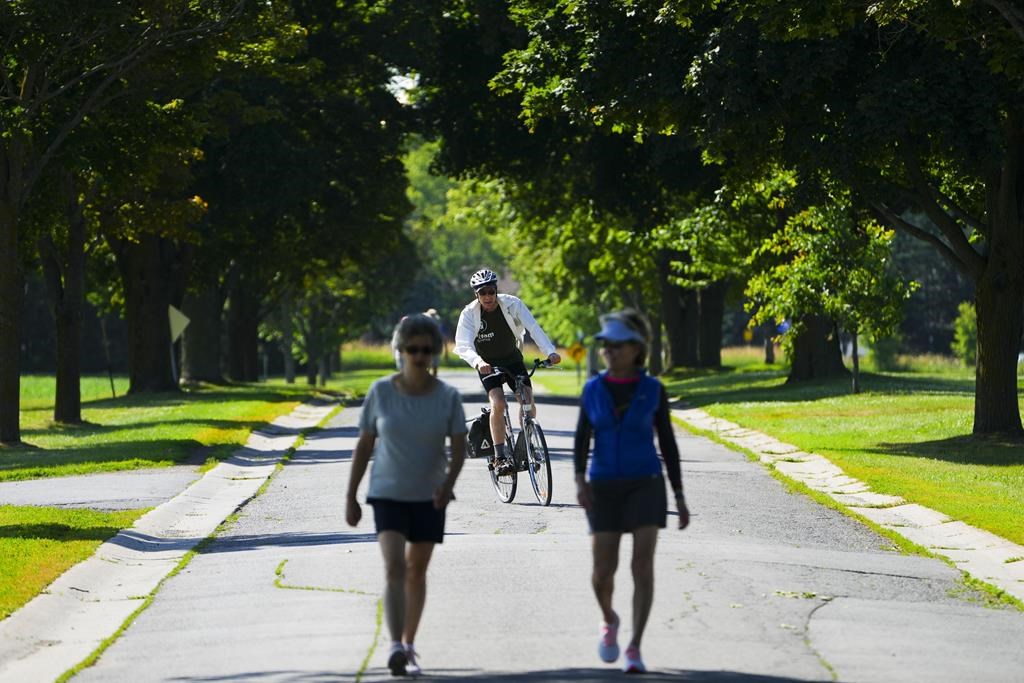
455, 268, 562, 473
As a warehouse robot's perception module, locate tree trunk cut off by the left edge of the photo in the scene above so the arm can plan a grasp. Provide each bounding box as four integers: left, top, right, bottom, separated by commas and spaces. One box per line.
0, 198, 25, 444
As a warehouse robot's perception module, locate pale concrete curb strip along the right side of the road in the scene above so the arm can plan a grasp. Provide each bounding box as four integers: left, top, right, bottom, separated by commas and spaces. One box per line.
672, 409, 1024, 601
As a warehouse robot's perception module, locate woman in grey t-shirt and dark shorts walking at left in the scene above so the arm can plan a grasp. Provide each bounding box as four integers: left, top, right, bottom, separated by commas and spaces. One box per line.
345, 313, 466, 676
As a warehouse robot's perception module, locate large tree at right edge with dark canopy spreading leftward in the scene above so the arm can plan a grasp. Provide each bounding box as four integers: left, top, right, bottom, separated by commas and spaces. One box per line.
502, 0, 1024, 434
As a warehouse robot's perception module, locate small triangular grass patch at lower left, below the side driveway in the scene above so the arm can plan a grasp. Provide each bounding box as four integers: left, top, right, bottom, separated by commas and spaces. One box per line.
0, 505, 145, 618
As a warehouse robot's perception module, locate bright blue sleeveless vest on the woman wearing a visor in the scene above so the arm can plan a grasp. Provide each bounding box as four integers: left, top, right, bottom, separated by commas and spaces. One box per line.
583, 371, 662, 479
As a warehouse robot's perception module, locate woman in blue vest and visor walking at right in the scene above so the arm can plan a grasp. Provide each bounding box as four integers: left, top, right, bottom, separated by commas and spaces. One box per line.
573, 309, 690, 673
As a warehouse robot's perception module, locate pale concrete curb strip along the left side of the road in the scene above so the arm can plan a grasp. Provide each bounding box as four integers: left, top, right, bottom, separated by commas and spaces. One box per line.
0, 404, 335, 682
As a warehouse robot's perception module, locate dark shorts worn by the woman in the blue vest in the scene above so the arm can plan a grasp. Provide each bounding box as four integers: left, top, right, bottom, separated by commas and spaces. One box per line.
587, 474, 669, 533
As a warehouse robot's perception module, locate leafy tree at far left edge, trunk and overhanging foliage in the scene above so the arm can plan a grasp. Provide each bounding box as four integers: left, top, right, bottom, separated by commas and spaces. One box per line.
0, 0, 241, 443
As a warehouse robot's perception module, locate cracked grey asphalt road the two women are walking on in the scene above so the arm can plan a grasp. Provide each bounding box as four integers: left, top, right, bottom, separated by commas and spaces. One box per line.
68, 374, 1024, 683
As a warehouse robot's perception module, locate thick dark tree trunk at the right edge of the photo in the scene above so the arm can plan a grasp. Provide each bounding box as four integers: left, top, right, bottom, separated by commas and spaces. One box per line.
974, 118, 1024, 435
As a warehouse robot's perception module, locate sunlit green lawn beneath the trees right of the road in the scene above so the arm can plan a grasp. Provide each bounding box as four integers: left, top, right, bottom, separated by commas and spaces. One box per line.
538, 348, 1024, 544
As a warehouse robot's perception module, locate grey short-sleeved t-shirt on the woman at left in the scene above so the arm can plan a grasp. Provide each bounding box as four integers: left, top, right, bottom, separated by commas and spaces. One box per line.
359, 376, 467, 502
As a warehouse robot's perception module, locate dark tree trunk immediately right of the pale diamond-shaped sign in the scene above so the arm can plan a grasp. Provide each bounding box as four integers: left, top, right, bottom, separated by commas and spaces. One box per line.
181, 286, 224, 384
